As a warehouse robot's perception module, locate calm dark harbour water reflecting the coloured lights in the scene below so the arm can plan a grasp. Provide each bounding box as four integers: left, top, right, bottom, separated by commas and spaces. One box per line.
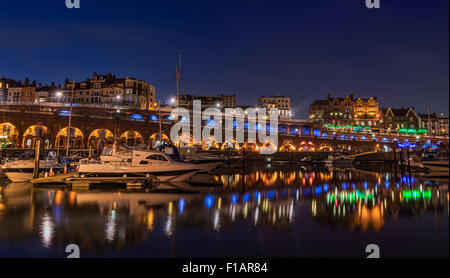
0, 167, 449, 257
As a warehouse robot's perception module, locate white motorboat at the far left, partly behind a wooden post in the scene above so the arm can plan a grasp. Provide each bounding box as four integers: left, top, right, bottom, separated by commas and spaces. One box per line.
2, 150, 64, 182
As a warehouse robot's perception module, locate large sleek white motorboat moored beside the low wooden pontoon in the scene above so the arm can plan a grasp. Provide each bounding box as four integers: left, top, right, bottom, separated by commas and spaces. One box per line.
78, 150, 219, 182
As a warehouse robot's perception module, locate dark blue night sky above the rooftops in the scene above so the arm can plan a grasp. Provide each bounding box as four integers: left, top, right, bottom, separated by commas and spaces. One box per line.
0, 0, 449, 116
